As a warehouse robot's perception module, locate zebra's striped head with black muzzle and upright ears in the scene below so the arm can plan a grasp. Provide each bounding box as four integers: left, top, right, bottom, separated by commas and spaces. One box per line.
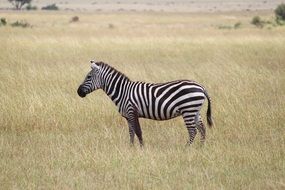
77, 60, 101, 98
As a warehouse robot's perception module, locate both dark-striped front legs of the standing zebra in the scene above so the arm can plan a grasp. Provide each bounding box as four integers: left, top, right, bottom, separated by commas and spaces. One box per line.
127, 115, 143, 146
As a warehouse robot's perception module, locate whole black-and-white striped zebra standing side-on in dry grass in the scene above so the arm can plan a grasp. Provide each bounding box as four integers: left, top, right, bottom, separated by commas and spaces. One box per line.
77, 60, 213, 146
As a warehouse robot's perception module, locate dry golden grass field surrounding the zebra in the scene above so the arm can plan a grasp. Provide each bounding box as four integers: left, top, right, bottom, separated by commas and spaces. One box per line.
0, 11, 285, 190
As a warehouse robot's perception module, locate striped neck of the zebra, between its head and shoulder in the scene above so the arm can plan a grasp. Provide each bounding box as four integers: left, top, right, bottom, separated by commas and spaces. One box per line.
103, 72, 132, 106
